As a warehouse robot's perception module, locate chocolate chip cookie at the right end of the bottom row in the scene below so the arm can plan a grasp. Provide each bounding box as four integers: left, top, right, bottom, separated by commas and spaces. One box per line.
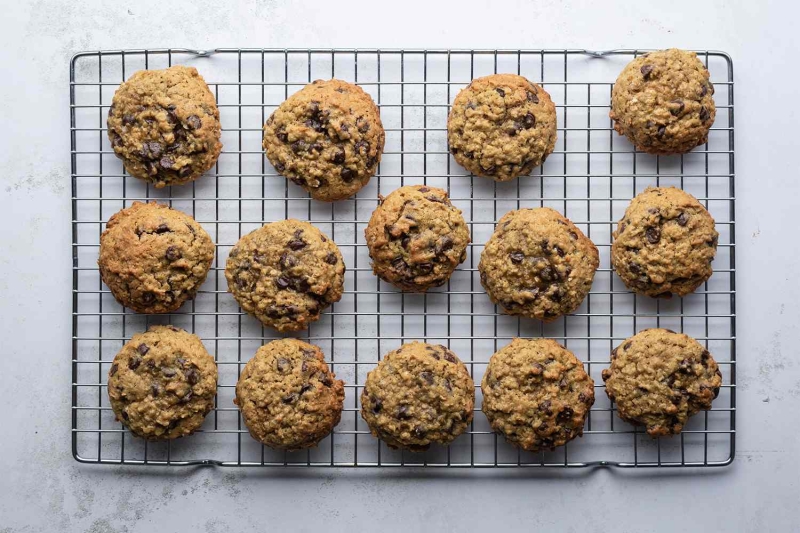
603, 329, 722, 437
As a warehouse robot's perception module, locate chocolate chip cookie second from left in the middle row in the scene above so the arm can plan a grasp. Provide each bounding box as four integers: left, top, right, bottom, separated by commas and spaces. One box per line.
225, 219, 345, 332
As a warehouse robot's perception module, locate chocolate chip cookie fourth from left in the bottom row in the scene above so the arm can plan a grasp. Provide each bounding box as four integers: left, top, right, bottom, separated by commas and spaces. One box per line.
481, 339, 594, 452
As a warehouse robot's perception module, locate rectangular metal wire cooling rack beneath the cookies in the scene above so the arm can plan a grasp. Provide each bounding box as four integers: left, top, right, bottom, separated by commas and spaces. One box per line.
70, 49, 736, 467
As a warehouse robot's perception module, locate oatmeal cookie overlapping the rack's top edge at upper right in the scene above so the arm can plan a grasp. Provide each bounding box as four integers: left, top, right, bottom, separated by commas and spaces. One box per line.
609, 48, 717, 155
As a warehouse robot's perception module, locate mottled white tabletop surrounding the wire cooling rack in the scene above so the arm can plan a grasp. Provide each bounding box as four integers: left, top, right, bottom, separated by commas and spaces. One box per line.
0, 0, 800, 533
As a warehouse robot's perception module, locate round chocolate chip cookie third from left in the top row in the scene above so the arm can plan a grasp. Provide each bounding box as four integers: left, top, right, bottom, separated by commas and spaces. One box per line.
447, 74, 557, 181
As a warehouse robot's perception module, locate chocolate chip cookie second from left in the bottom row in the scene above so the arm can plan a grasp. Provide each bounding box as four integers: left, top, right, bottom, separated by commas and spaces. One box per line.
234, 339, 344, 451
